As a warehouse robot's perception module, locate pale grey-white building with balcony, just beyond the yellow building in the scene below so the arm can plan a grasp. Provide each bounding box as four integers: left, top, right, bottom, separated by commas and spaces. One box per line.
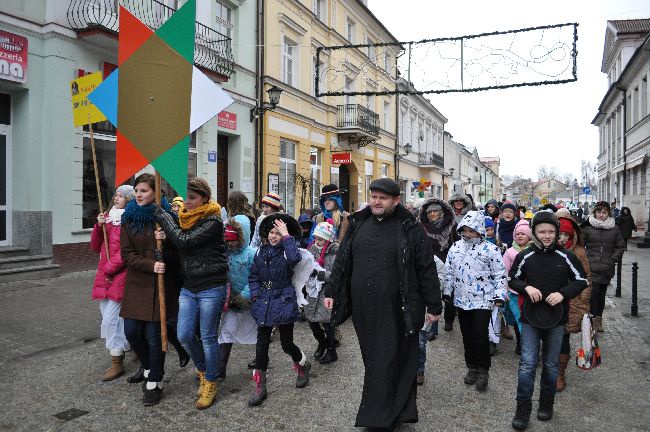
396, 79, 447, 202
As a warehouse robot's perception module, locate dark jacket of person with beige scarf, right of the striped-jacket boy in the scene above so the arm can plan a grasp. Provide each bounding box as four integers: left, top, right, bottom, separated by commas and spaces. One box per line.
581, 219, 625, 284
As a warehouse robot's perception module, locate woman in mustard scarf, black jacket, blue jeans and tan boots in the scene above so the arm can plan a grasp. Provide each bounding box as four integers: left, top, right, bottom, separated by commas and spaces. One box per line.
156, 178, 228, 409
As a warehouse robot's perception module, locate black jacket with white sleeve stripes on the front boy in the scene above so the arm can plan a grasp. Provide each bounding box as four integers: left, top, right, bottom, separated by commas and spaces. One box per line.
508, 243, 589, 324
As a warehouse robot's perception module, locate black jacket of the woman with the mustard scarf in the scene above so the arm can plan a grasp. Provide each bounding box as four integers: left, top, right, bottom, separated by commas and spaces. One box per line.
156, 209, 228, 293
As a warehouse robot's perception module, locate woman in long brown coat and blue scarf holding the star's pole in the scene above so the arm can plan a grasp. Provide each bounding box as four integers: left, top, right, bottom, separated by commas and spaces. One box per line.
120, 174, 180, 406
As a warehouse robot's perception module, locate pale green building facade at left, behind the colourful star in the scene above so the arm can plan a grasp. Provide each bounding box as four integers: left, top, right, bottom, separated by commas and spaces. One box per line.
0, 0, 251, 264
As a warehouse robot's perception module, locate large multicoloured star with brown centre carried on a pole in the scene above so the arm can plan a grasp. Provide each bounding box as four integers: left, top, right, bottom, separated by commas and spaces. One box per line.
88, 0, 233, 194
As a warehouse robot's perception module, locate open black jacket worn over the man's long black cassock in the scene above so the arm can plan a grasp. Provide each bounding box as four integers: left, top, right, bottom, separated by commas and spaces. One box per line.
324, 204, 442, 335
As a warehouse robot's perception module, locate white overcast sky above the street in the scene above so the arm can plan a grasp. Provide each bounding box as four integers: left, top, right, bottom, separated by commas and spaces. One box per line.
368, 0, 650, 178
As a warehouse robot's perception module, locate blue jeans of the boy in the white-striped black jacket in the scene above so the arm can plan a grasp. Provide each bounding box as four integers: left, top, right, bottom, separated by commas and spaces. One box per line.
517, 323, 564, 401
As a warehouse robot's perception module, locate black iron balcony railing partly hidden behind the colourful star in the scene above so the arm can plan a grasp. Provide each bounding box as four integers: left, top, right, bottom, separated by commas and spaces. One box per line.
67, 0, 233, 81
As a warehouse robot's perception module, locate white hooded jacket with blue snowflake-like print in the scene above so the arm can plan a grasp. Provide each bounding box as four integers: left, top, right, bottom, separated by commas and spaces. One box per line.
443, 211, 508, 310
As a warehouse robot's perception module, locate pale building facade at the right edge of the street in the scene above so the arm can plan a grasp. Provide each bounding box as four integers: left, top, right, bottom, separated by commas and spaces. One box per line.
592, 19, 650, 225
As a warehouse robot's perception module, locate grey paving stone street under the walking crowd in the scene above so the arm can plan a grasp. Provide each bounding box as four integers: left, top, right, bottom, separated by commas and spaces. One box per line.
0, 249, 650, 432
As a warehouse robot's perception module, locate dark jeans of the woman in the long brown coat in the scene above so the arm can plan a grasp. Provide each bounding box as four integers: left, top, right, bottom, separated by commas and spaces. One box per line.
124, 318, 165, 382
